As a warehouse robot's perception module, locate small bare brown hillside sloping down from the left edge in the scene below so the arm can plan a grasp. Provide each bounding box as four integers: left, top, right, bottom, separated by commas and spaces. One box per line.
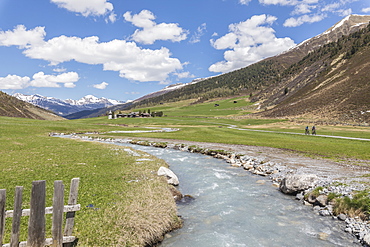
0, 91, 64, 120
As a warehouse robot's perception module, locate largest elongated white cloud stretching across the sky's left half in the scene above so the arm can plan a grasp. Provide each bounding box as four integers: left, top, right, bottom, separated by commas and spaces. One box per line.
0, 25, 182, 82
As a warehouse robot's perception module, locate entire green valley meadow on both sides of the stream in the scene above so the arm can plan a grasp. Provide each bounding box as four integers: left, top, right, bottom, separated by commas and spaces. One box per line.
0, 97, 370, 246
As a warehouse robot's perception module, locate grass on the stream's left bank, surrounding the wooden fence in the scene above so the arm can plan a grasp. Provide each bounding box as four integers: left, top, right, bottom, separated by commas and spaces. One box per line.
0, 117, 179, 246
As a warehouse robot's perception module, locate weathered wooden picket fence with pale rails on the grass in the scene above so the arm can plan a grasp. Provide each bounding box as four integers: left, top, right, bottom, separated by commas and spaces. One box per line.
0, 178, 81, 247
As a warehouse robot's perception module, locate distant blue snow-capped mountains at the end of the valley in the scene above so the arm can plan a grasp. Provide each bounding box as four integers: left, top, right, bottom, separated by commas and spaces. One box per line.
13, 93, 124, 116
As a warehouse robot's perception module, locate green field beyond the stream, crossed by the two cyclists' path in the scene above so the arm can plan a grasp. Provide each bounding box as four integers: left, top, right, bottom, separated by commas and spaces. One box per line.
97, 97, 370, 160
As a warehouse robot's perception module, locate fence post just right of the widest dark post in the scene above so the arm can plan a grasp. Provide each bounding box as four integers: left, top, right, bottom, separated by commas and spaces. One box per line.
52, 180, 64, 247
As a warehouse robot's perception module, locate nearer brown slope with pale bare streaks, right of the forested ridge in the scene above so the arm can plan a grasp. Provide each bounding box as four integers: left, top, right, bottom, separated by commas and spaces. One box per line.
259, 25, 370, 123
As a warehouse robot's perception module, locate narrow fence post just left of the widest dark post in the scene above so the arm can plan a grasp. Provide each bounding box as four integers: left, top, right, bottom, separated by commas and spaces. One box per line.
10, 186, 23, 247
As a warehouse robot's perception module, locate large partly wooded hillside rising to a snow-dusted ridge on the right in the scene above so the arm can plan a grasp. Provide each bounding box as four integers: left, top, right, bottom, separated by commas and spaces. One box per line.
127, 15, 370, 123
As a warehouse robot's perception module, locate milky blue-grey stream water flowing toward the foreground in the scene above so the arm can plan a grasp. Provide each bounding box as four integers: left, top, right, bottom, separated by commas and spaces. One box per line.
113, 144, 358, 247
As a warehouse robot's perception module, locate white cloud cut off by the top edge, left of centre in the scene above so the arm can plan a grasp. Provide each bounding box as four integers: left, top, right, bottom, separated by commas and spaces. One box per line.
50, 0, 113, 17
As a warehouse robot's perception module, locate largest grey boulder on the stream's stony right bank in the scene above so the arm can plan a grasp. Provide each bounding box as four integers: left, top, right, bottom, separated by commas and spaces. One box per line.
279, 174, 317, 195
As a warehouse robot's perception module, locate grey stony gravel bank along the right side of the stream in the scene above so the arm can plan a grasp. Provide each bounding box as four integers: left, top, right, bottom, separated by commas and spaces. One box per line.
54, 134, 370, 246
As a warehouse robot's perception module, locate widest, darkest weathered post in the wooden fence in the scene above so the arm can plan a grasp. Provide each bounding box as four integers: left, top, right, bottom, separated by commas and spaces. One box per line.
27, 180, 46, 247
